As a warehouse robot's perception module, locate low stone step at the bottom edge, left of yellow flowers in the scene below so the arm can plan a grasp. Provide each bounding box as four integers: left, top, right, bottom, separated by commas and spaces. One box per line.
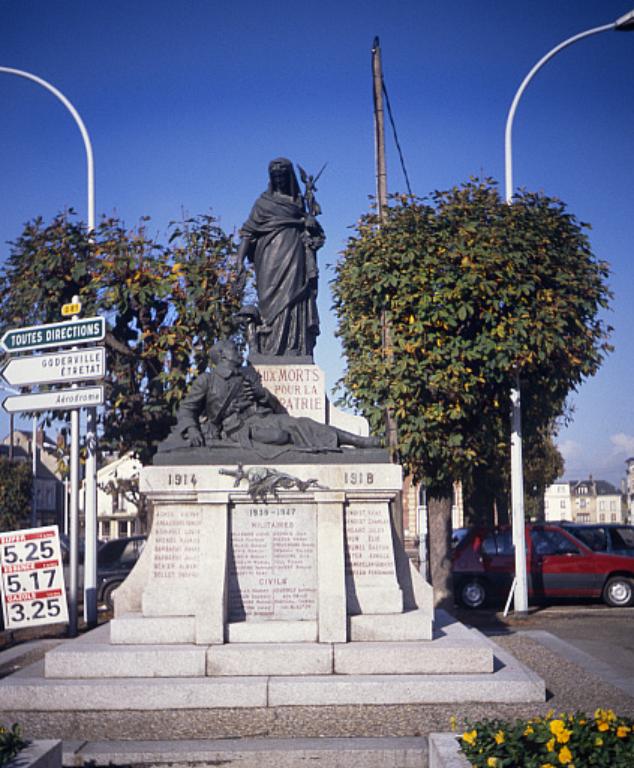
63, 737, 427, 768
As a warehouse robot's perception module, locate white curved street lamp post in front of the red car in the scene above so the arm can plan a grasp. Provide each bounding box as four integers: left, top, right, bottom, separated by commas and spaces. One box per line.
504, 10, 634, 615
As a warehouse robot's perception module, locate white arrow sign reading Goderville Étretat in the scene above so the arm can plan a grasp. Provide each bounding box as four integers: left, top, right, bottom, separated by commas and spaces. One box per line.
0, 347, 106, 387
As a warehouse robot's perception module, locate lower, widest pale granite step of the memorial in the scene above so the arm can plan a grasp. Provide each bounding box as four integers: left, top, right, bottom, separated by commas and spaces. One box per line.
0, 638, 545, 721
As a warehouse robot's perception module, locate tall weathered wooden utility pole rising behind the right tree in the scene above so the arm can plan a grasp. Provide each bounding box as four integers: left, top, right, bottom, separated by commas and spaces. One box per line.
372, 37, 403, 541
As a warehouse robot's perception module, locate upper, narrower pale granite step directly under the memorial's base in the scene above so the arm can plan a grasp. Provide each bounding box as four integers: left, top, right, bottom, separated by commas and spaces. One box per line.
45, 611, 493, 679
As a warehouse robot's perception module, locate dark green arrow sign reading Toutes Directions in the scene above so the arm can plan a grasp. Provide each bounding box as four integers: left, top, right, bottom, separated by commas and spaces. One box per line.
0, 317, 106, 353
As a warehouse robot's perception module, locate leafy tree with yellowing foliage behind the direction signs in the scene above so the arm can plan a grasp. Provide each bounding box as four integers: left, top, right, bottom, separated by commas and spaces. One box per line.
0, 211, 241, 461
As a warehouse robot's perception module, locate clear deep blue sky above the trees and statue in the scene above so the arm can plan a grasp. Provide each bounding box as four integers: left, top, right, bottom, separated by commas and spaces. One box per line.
0, 0, 634, 482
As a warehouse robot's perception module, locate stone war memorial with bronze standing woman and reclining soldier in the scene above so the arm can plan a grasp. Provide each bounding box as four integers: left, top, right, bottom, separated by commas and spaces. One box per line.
0, 158, 545, 760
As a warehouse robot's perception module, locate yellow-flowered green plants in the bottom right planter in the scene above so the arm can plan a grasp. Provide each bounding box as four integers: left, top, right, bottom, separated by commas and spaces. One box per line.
452, 709, 634, 768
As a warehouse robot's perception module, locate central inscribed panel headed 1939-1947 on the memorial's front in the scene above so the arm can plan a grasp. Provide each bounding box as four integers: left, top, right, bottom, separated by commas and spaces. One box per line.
229, 504, 317, 621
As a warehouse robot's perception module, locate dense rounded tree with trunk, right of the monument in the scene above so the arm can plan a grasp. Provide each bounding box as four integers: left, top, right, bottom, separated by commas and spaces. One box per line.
333, 180, 610, 600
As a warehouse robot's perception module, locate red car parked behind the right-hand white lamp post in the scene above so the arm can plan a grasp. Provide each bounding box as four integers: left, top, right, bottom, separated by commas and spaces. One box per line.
452, 523, 634, 608
